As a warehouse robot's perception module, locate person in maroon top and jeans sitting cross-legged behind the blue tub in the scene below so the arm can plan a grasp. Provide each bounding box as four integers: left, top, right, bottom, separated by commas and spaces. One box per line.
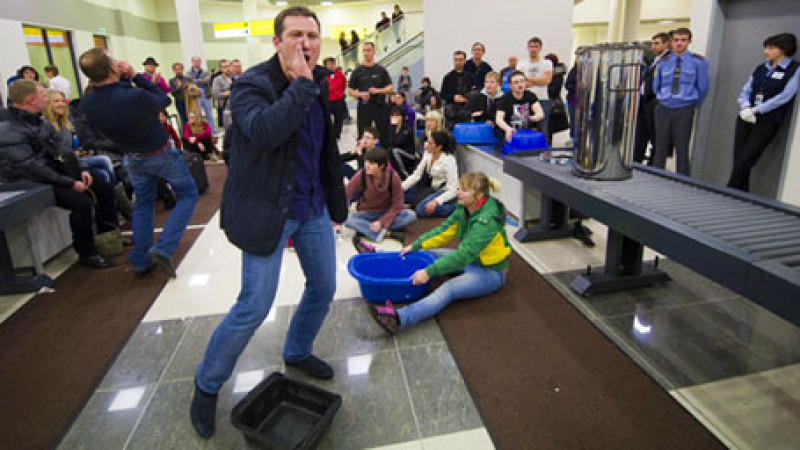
344, 147, 417, 244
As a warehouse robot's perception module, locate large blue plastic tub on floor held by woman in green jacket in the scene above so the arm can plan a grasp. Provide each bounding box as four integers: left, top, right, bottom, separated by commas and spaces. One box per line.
347, 251, 436, 303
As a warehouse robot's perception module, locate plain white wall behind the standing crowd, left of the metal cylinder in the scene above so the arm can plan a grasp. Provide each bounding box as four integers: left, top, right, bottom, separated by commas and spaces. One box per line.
424, 0, 573, 88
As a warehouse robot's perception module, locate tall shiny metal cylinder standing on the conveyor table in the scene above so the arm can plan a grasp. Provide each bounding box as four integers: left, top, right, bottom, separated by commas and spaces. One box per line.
572, 42, 646, 180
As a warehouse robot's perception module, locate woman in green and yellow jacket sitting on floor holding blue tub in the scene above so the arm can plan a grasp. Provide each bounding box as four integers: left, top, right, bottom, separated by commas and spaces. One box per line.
372, 172, 511, 335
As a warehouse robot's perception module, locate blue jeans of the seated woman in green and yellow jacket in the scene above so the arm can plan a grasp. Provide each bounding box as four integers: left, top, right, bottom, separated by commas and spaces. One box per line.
397, 249, 506, 328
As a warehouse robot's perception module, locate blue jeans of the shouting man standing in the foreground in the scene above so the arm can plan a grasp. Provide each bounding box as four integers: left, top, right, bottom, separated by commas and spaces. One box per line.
195, 210, 336, 394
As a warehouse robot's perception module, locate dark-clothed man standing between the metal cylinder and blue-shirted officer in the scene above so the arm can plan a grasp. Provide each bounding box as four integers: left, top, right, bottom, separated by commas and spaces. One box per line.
633, 32, 669, 165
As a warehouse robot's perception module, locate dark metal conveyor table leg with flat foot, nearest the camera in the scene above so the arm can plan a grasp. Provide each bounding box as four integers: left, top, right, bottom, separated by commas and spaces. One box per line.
570, 229, 670, 295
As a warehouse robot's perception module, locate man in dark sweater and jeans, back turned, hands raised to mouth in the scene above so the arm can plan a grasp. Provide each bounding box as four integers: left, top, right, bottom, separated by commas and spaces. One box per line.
79, 48, 197, 278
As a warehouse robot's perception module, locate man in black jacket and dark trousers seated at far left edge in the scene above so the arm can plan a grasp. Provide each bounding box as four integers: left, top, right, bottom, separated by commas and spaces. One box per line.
0, 80, 117, 269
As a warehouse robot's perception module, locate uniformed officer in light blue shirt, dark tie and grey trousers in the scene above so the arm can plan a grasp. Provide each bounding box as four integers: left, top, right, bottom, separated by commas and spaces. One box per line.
653, 28, 708, 175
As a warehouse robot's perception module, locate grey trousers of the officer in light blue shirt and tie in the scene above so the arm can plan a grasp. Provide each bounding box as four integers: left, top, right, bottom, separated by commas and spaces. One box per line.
653, 104, 695, 175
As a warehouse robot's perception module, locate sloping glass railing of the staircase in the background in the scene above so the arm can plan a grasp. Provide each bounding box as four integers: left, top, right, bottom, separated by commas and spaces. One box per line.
337, 11, 425, 72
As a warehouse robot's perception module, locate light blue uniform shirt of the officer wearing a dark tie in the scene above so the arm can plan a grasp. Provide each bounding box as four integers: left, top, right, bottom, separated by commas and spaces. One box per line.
653, 51, 708, 109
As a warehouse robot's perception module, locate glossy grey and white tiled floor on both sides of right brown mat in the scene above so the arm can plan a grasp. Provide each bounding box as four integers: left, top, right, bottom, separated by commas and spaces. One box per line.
25, 122, 800, 449
